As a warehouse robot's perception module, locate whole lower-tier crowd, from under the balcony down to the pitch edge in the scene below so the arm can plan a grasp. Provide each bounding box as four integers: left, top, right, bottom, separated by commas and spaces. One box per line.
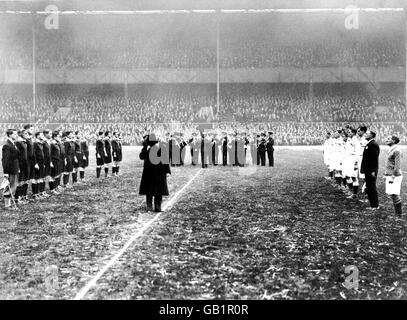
0, 84, 407, 145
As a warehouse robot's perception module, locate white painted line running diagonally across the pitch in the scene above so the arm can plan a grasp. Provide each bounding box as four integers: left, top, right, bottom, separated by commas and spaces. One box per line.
74, 168, 202, 300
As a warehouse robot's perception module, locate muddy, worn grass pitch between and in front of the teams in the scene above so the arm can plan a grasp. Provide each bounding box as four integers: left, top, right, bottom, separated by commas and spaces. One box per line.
0, 148, 407, 299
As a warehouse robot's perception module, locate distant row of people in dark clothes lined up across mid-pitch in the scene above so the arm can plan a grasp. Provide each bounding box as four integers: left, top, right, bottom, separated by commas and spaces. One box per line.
144, 132, 274, 168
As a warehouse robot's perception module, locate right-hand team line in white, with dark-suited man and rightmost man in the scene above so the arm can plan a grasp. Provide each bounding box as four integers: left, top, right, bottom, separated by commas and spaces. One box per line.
324, 125, 403, 217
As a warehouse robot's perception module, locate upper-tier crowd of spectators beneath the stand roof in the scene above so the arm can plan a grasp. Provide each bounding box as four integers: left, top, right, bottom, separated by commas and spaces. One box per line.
0, 36, 405, 69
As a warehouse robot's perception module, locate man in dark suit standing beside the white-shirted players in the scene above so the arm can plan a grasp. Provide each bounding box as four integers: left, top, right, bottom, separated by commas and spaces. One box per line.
360, 131, 380, 210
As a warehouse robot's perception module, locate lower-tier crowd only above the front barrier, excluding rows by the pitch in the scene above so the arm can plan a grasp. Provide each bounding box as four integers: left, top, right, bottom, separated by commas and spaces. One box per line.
0, 84, 407, 123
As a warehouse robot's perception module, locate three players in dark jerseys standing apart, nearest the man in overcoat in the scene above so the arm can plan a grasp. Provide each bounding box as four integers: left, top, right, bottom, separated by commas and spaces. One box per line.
96, 131, 123, 179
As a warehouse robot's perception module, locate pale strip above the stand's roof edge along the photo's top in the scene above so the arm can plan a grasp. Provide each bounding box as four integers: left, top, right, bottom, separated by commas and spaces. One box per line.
0, 0, 407, 11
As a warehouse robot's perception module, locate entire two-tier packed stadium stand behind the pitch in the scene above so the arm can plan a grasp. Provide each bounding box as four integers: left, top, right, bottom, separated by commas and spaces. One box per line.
0, 3, 407, 145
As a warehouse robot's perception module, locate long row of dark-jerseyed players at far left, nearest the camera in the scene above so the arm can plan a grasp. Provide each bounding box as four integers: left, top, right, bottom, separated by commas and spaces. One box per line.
2, 125, 89, 210
